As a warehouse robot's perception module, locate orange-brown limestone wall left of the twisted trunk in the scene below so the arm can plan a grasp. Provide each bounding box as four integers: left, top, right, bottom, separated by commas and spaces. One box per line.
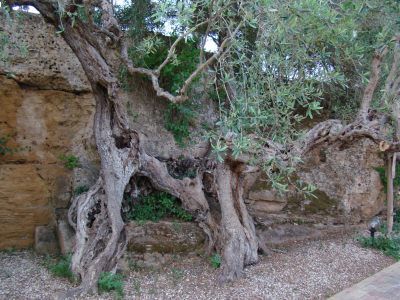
0, 76, 98, 249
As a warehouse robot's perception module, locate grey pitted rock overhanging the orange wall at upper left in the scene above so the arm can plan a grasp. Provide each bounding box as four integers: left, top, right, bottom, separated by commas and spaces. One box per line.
0, 13, 92, 92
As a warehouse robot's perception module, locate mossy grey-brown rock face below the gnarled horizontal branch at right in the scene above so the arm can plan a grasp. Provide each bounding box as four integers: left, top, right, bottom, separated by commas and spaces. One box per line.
245, 139, 384, 224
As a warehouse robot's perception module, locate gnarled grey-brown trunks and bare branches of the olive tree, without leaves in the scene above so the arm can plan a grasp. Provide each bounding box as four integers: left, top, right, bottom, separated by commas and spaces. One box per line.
5, 0, 400, 298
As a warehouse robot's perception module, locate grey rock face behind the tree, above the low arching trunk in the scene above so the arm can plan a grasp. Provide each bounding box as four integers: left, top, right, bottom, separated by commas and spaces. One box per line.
119, 79, 217, 159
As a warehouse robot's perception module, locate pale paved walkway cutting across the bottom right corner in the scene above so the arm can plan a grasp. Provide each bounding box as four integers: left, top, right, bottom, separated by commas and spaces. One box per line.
329, 262, 400, 300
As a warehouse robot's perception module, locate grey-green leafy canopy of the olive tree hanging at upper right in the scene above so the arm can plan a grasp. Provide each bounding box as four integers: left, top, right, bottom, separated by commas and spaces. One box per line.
148, 0, 399, 192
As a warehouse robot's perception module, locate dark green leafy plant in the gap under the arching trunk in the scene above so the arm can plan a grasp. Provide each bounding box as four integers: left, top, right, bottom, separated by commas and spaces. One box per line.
126, 191, 192, 222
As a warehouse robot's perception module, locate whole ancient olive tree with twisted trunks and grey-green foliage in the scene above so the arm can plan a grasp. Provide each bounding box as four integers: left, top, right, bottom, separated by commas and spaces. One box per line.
2, 0, 400, 297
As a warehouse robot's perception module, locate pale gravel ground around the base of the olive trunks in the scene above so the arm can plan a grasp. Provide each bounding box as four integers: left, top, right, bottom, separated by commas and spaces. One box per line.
0, 226, 395, 300
